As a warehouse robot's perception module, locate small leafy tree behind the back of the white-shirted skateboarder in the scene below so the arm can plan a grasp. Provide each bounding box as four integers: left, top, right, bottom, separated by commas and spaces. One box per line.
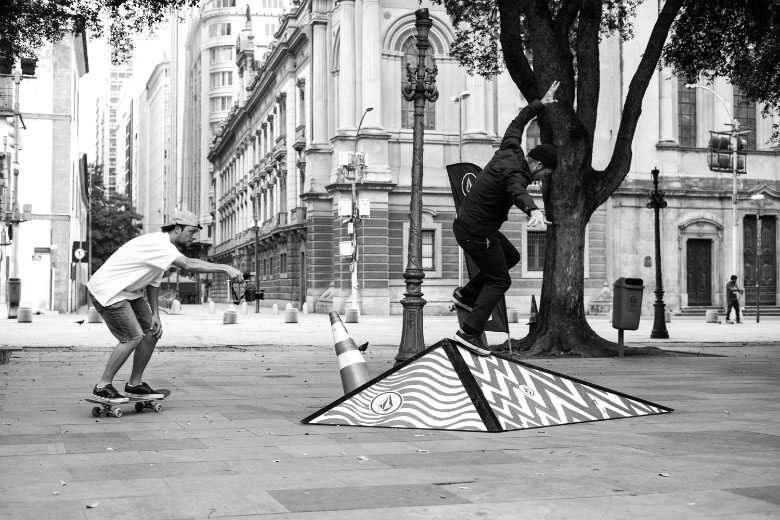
90, 164, 143, 273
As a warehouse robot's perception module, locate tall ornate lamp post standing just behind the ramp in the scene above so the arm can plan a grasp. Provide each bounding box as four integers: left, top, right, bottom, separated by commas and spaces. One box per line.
395, 9, 439, 363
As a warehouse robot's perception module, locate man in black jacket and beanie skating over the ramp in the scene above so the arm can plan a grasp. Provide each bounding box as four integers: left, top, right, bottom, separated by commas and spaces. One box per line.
452, 81, 560, 356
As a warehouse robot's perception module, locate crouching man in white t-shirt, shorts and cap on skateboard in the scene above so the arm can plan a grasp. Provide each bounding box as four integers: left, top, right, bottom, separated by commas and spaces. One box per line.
87, 211, 241, 404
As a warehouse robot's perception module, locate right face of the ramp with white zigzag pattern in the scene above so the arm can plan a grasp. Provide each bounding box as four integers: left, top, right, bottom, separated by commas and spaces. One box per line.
461, 349, 668, 430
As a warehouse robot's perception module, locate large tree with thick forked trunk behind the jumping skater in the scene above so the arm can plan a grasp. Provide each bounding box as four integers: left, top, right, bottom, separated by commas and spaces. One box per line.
434, 0, 780, 356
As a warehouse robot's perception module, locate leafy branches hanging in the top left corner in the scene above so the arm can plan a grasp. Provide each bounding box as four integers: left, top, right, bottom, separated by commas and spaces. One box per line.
0, 0, 195, 63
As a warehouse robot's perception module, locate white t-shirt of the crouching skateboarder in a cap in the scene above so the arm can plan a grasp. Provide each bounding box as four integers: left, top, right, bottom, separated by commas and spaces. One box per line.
87, 231, 184, 307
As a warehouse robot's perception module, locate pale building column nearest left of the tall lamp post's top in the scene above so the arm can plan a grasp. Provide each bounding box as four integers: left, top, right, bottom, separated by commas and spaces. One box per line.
360, 0, 382, 130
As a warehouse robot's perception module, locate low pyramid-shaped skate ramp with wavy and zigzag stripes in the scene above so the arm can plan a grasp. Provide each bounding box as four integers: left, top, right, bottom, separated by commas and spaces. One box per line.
301, 339, 672, 432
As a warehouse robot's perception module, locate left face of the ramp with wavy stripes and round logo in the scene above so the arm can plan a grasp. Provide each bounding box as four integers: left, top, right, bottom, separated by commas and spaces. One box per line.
310, 348, 486, 431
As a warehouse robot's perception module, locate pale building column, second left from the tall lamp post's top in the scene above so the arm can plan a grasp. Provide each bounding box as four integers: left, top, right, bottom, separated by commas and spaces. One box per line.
338, 0, 357, 132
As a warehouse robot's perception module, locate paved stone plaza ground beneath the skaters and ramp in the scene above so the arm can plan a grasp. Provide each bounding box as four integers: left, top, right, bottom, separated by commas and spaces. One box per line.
0, 311, 780, 520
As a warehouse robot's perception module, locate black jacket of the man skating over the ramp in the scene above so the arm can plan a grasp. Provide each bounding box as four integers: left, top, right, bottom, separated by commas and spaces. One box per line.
458, 100, 544, 236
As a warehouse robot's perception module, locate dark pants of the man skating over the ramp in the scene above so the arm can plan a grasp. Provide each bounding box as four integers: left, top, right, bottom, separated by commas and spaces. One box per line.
452, 219, 520, 334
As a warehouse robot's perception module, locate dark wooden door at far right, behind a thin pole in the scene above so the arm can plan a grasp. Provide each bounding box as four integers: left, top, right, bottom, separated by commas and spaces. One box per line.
740, 215, 777, 306
